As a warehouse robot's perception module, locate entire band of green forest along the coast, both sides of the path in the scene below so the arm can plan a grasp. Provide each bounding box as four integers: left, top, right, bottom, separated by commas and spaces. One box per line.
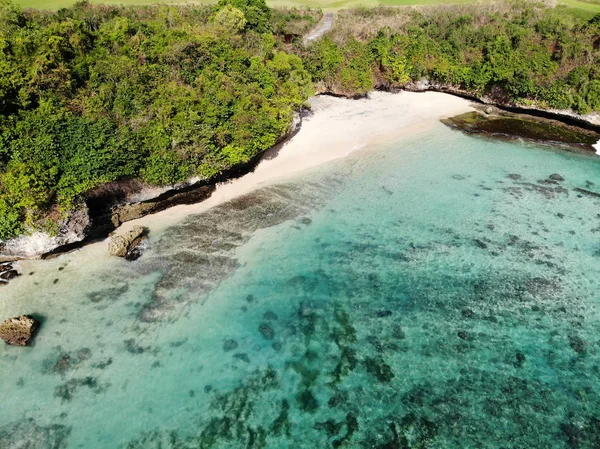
0, 0, 600, 240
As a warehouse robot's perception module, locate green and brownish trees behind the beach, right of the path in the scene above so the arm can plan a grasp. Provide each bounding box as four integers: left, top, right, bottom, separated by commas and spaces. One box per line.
297, 2, 600, 107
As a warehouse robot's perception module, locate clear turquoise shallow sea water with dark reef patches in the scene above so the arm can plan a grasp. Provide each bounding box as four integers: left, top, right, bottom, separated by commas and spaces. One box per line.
0, 125, 600, 449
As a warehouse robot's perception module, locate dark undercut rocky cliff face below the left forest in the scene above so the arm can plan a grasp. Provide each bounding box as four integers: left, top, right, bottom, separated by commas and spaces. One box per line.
0, 114, 302, 261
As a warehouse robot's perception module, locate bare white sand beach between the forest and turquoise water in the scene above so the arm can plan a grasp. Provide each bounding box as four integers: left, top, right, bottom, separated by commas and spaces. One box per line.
117, 92, 472, 232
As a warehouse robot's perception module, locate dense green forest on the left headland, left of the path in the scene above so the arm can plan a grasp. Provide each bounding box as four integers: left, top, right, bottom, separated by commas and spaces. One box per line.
0, 0, 311, 239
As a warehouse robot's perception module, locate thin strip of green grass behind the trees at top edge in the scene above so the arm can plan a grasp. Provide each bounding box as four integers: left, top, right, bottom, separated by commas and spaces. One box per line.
7, 0, 600, 18
